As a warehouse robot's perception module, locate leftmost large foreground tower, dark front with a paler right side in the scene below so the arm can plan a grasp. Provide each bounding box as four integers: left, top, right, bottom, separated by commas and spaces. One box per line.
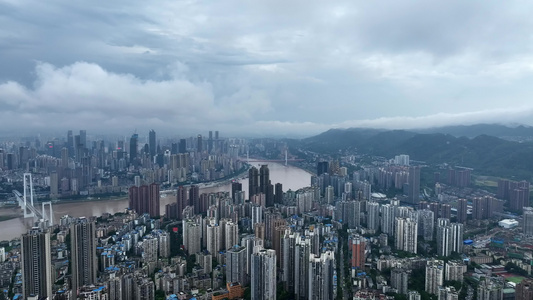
21, 228, 53, 299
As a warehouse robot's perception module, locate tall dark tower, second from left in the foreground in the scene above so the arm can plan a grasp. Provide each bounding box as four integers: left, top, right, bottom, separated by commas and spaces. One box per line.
70, 218, 98, 294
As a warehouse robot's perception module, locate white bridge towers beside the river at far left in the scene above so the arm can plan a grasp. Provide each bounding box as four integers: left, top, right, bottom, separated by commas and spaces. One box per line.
13, 173, 54, 226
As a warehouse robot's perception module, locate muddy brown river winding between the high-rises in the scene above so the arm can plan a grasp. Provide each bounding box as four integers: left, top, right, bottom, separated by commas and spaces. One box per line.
0, 163, 311, 241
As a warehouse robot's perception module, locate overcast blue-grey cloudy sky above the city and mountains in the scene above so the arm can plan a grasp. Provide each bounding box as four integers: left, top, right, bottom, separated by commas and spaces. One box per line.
0, 0, 533, 135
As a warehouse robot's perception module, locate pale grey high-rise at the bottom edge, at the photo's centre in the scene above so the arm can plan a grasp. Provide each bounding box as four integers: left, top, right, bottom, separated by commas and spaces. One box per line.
250, 247, 274, 300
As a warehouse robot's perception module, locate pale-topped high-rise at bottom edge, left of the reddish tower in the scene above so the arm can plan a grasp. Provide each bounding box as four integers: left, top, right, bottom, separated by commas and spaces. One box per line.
308, 251, 335, 300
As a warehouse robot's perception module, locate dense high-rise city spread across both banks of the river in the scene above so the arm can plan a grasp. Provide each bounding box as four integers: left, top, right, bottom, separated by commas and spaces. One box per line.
0, 129, 533, 300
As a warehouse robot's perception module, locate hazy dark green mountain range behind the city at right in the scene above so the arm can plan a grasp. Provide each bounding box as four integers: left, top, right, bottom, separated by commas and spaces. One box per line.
295, 124, 533, 180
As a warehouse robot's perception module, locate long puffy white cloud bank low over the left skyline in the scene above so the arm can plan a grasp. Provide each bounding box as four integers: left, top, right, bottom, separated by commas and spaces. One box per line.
0, 62, 269, 134
